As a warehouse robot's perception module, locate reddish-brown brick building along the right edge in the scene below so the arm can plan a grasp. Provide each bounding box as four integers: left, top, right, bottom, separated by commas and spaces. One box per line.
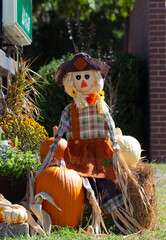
128, 0, 166, 162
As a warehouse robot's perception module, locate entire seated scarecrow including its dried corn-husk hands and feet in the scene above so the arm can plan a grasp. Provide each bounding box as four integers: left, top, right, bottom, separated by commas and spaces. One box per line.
39, 53, 157, 234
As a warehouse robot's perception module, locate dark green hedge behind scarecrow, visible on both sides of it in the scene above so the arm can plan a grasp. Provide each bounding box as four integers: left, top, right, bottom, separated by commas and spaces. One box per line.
39, 53, 147, 151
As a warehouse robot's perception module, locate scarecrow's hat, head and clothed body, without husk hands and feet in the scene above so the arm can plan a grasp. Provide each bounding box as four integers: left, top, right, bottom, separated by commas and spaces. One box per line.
54, 53, 123, 232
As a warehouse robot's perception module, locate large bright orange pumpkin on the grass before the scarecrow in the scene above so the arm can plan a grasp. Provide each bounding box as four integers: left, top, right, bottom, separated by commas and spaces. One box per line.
35, 159, 85, 227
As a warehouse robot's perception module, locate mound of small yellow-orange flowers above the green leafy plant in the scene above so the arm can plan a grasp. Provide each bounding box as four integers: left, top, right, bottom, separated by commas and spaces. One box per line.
0, 114, 48, 152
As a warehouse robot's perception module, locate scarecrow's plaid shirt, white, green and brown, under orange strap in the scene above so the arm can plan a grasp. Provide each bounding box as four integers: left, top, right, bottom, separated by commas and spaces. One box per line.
54, 104, 115, 143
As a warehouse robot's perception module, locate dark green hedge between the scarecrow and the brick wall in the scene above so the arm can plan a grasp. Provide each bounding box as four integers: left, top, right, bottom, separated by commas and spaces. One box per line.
111, 53, 148, 149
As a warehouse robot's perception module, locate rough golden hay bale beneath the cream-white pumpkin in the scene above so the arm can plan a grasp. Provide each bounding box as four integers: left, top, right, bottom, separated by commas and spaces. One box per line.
128, 164, 157, 229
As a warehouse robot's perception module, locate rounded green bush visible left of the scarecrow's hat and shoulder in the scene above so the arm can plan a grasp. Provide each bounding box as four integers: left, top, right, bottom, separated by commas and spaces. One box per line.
38, 54, 73, 136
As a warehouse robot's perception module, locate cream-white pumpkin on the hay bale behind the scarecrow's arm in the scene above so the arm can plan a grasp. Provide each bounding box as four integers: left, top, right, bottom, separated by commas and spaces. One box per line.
116, 128, 141, 167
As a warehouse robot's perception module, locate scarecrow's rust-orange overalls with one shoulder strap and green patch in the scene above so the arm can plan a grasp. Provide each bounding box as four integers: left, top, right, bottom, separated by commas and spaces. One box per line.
64, 103, 115, 180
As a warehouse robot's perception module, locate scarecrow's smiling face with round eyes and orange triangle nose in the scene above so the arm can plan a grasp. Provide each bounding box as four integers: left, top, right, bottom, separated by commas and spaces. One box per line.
72, 70, 97, 95
